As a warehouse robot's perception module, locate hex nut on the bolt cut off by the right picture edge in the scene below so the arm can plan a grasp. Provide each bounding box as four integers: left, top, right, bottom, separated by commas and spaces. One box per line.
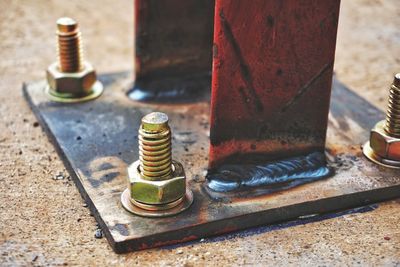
370, 121, 400, 161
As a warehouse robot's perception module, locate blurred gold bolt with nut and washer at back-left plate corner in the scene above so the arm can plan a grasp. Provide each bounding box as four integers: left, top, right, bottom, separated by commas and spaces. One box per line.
46, 17, 103, 103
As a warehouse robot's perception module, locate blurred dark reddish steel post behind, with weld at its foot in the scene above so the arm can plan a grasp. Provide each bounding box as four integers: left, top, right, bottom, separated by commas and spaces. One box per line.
129, 0, 214, 101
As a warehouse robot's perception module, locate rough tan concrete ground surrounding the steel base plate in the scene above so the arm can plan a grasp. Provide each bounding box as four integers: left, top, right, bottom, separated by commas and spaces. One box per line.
0, 0, 400, 266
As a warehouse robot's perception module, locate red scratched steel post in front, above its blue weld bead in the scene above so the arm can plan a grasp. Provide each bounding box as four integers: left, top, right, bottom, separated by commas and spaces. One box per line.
209, 0, 340, 170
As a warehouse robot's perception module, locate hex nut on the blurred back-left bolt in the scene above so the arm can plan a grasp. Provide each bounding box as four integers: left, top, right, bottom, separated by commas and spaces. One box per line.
46, 62, 97, 95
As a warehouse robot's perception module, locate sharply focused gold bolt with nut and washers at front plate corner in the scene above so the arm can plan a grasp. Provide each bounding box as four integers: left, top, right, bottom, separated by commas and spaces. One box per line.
121, 112, 193, 217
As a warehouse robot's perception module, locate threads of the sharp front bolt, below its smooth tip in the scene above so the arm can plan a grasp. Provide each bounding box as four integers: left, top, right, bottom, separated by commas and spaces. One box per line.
139, 117, 172, 180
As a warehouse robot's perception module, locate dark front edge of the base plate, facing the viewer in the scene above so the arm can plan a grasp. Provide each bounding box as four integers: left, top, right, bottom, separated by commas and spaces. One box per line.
114, 185, 400, 253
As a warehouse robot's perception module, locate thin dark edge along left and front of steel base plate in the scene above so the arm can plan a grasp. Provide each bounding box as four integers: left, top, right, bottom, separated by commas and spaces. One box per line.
22, 83, 400, 254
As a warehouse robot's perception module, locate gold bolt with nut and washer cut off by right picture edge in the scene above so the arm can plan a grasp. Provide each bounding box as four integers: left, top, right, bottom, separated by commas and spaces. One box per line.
363, 73, 400, 168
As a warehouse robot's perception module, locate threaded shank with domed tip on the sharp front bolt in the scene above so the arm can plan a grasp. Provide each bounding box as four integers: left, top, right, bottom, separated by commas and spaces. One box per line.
139, 112, 172, 181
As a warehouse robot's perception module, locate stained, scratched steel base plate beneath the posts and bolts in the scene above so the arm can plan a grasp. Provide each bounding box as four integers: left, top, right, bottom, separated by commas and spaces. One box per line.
24, 73, 400, 253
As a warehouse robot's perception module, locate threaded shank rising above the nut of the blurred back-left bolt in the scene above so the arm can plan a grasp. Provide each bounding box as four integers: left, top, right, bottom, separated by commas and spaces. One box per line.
57, 18, 83, 73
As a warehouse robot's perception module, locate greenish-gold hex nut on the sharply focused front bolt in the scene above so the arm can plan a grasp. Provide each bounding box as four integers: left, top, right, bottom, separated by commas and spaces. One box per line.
128, 161, 186, 205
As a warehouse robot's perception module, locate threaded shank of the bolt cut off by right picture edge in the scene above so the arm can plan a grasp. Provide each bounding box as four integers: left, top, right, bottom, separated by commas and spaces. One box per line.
385, 73, 400, 137
